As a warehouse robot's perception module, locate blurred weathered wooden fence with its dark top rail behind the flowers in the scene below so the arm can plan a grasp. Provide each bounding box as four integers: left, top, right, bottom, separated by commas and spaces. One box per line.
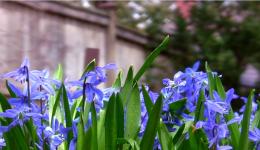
0, 1, 169, 83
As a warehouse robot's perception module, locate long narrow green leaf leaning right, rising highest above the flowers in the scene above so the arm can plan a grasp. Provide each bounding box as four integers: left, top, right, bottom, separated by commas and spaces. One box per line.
134, 36, 170, 82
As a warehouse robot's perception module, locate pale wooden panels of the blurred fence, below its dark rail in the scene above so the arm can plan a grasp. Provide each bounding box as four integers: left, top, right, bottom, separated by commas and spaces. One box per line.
0, 2, 145, 79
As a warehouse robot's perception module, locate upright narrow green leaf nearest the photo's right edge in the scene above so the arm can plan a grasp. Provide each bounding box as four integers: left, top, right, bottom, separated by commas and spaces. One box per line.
239, 90, 255, 150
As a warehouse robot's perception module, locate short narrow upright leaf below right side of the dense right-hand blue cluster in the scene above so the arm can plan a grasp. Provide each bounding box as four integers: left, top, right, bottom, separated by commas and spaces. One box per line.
194, 89, 205, 123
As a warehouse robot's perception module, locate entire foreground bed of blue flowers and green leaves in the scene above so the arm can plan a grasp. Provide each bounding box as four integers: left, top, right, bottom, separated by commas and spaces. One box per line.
0, 37, 260, 150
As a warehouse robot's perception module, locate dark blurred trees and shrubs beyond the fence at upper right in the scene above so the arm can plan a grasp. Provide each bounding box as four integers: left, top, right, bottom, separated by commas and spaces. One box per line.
117, 1, 260, 94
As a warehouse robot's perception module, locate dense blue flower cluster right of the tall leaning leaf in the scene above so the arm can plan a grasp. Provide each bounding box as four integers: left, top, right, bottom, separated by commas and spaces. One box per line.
161, 62, 208, 112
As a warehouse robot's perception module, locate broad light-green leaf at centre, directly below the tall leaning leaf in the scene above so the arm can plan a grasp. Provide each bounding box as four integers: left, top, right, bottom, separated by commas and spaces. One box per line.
125, 84, 141, 139
